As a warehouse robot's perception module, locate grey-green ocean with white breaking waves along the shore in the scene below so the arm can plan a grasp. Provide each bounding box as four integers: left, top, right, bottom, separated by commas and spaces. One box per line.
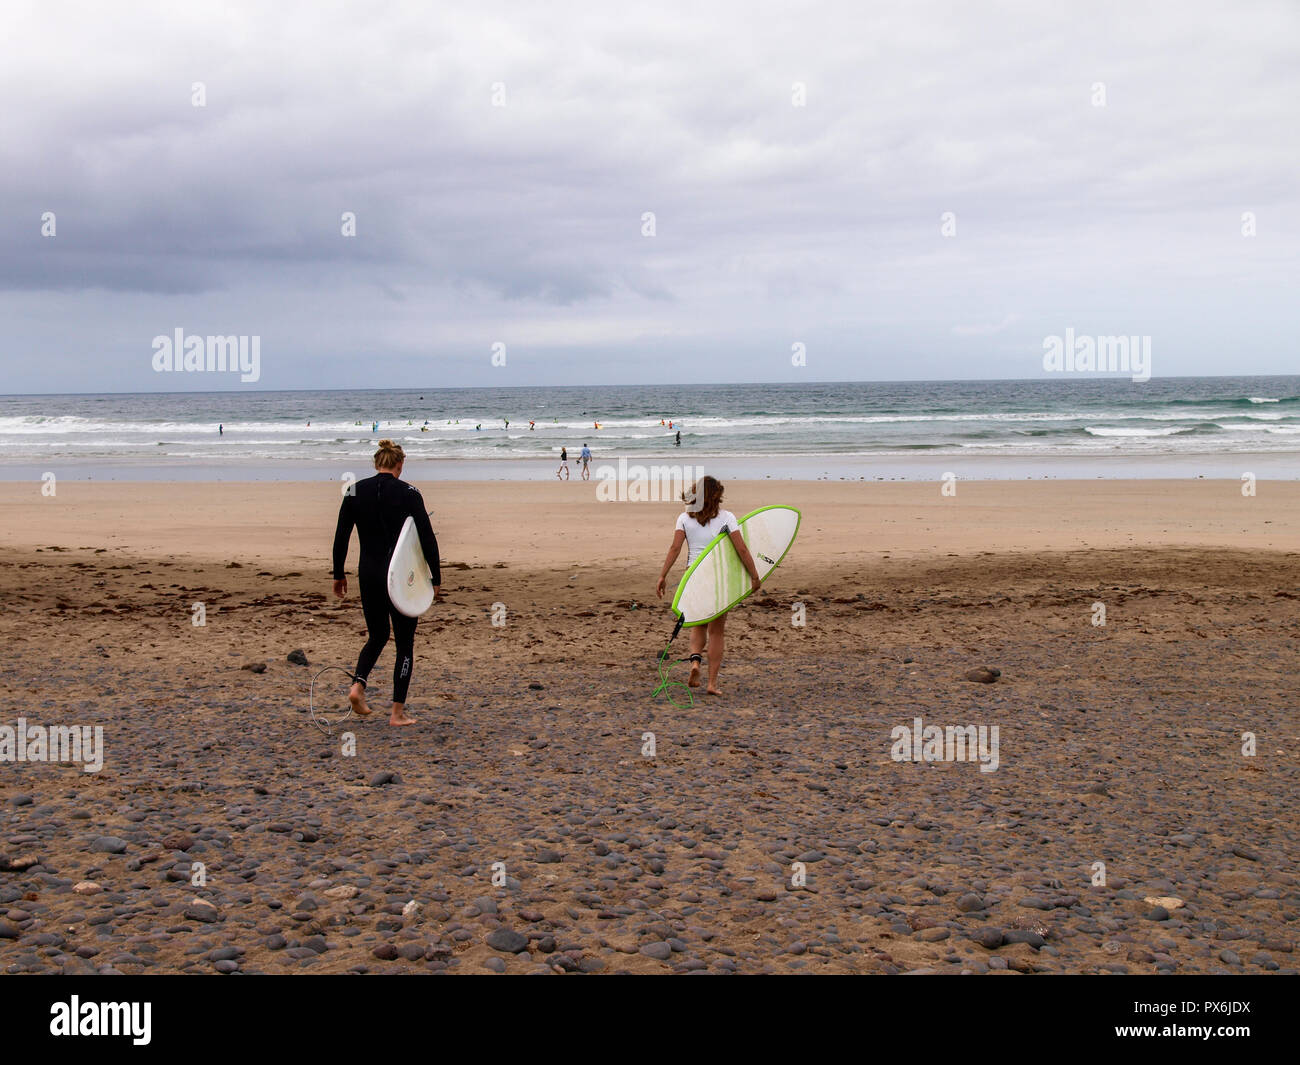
0, 376, 1300, 480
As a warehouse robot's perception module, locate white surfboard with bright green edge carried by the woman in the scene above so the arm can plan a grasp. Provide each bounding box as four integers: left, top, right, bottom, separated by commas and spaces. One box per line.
672, 506, 802, 627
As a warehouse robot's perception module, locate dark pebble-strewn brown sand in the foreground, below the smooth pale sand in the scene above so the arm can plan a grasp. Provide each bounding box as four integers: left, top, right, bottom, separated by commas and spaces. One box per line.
0, 538, 1300, 975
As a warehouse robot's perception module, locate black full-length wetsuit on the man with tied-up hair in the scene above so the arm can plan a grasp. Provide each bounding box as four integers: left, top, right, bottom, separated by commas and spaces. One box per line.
334, 473, 442, 702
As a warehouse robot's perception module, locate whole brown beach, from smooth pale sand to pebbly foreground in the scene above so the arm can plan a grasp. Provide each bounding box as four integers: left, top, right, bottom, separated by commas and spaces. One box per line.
0, 480, 1300, 973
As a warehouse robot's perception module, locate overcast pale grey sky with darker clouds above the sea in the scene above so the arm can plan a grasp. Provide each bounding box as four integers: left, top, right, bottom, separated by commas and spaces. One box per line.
0, 0, 1300, 393
